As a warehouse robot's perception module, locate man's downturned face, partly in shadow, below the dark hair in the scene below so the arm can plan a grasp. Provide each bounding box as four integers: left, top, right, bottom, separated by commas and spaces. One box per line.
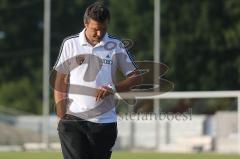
84, 19, 108, 45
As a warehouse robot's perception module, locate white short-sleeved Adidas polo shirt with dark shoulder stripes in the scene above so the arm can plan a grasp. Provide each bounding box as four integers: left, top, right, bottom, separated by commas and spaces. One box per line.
54, 29, 136, 123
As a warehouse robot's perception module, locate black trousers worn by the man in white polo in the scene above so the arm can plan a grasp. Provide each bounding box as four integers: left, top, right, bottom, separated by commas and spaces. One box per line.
58, 114, 117, 159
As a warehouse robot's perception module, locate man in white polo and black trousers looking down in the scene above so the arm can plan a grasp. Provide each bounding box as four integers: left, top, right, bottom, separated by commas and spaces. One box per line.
54, 2, 141, 159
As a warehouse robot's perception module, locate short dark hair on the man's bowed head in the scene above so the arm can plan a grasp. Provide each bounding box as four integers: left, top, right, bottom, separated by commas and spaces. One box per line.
83, 2, 110, 23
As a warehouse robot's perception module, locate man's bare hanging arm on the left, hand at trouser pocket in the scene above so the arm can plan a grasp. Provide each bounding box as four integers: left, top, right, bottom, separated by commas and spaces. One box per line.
54, 72, 69, 118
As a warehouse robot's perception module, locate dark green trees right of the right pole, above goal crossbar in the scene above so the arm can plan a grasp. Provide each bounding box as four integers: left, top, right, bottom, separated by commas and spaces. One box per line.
161, 0, 240, 91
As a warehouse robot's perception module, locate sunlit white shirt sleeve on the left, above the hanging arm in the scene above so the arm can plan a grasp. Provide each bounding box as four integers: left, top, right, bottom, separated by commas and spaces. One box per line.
53, 41, 70, 74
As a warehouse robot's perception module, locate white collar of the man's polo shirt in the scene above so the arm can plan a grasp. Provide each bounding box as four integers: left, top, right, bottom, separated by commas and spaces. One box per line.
79, 28, 108, 46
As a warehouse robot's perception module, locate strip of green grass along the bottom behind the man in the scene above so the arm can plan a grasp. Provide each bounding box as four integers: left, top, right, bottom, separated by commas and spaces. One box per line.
0, 152, 240, 159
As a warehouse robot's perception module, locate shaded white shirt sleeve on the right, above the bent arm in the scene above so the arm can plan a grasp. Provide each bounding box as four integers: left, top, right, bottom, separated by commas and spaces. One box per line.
117, 44, 137, 76
